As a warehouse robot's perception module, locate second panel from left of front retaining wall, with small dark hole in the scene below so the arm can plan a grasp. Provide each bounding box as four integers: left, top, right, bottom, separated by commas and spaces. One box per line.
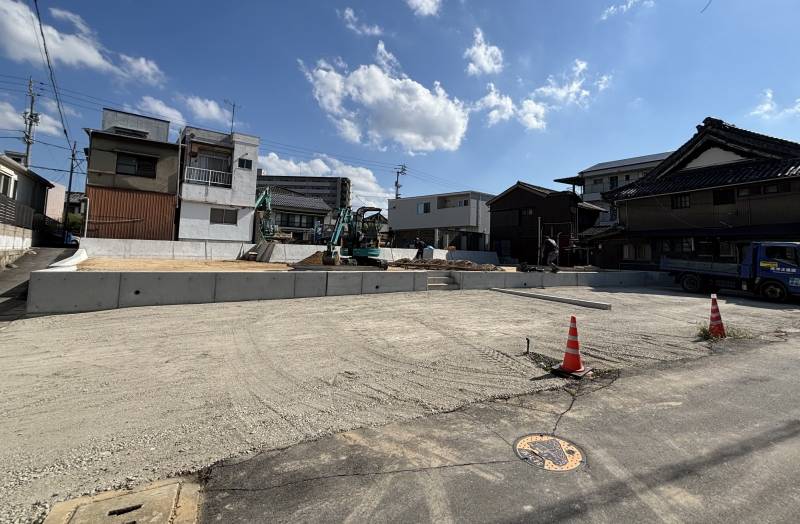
119, 272, 215, 307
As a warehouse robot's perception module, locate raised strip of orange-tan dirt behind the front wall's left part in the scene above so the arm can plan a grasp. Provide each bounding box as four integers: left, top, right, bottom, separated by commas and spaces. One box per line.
78, 257, 291, 271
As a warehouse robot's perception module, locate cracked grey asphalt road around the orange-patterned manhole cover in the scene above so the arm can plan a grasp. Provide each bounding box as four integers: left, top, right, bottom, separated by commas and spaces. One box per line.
201, 336, 800, 523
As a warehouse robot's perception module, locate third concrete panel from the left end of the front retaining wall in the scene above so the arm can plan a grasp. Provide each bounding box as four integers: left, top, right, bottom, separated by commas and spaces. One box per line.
214, 271, 295, 302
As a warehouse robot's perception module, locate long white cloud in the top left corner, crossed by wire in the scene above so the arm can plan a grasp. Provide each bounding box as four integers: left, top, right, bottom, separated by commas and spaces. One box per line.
0, 0, 163, 85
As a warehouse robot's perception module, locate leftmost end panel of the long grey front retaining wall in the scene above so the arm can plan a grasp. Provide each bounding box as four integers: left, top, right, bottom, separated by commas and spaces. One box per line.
28, 270, 120, 314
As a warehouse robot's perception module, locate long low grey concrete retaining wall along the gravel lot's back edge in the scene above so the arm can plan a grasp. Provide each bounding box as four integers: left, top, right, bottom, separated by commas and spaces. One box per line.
28, 267, 670, 314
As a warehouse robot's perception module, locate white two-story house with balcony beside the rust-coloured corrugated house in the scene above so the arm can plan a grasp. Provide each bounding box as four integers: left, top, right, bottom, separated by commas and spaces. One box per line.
178, 126, 260, 242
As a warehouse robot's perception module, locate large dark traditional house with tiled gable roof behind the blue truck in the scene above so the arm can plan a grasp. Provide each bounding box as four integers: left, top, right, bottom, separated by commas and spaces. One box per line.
598, 118, 800, 268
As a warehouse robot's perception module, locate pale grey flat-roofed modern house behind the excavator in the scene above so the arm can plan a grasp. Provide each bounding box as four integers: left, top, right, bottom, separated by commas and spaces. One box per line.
389, 191, 494, 251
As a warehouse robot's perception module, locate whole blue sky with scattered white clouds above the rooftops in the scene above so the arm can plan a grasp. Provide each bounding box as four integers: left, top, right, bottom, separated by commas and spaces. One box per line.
0, 0, 800, 206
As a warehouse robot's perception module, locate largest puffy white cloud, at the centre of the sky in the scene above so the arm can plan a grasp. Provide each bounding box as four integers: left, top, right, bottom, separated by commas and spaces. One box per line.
300, 43, 469, 153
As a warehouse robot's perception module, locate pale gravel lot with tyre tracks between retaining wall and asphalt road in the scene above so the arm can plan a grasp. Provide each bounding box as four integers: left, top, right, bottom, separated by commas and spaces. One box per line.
0, 288, 800, 521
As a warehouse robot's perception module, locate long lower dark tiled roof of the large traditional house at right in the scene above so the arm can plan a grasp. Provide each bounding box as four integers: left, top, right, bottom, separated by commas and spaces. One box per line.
603, 158, 800, 200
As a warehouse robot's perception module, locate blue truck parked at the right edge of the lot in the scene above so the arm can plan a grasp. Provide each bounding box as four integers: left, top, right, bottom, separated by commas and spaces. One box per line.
660, 242, 800, 301
